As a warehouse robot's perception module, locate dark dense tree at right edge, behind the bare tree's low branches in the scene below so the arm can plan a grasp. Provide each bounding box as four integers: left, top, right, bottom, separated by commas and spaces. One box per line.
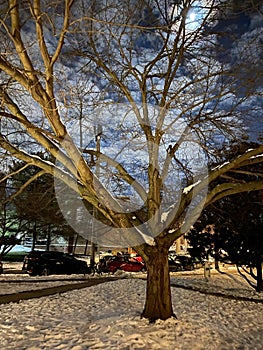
187, 142, 263, 291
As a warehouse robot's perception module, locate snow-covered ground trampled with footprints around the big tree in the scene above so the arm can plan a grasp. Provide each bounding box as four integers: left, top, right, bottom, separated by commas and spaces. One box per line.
0, 264, 263, 350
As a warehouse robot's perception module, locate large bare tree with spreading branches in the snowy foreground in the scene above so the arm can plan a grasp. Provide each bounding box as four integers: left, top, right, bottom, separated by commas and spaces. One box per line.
0, 0, 263, 320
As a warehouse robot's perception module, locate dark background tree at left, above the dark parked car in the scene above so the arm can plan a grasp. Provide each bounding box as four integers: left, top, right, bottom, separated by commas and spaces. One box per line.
7, 158, 85, 253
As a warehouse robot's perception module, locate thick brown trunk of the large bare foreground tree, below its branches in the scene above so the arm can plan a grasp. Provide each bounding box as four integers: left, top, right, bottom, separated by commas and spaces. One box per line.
142, 250, 175, 322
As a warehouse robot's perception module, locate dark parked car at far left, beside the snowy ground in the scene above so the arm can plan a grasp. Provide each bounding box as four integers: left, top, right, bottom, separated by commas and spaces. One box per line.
22, 251, 91, 276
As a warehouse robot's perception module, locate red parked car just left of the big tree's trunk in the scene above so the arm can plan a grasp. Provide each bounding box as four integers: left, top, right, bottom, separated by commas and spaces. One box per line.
97, 255, 146, 273
